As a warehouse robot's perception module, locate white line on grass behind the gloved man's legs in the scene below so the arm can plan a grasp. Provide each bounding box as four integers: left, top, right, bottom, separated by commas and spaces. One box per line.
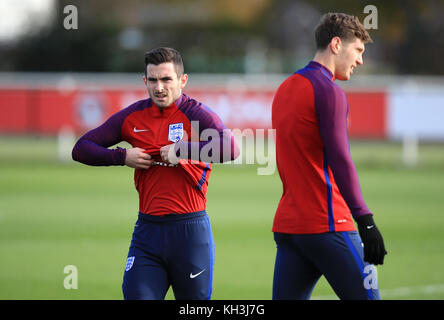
312, 283, 444, 300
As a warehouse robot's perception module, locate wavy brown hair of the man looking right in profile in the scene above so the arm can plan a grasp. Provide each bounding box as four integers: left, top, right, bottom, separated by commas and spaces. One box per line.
315, 12, 373, 50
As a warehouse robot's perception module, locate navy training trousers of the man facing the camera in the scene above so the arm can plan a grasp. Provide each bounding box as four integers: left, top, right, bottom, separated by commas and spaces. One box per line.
122, 211, 214, 300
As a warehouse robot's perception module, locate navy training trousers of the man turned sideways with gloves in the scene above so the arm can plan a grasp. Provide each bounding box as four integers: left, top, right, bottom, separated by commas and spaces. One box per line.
273, 231, 379, 300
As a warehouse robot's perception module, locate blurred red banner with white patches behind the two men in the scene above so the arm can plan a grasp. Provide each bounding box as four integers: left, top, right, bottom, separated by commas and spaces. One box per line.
0, 88, 387, 138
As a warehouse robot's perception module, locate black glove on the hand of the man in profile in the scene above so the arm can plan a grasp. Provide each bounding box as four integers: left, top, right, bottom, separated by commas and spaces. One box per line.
356, 214, 387, 265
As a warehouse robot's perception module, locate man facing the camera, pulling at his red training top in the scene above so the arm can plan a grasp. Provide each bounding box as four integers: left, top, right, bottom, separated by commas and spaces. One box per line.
72, 48, 239, 300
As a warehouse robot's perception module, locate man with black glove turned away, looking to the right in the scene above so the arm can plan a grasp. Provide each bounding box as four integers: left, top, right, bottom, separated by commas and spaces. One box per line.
272, 13, 387, 299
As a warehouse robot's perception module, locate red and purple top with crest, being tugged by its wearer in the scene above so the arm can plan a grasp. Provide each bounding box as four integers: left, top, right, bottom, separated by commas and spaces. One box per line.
72, 94, 238, 215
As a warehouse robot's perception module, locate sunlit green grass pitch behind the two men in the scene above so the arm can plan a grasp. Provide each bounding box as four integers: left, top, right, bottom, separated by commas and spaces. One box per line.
0, 137, 444, 299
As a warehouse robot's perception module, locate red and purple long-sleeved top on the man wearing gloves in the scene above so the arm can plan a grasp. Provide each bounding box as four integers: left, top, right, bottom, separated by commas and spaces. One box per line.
272, 61, 371, 234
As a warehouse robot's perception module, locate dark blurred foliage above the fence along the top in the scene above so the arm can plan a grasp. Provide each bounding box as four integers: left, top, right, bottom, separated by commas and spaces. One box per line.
0, 0, 444, 75
